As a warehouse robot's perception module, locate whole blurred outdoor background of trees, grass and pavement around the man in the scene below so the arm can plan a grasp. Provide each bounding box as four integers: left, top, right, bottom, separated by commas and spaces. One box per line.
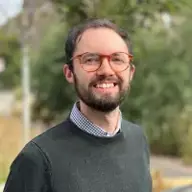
0, 0, 192, 192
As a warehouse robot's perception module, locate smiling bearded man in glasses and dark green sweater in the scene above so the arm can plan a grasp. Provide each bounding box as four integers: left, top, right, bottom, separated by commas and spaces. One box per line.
5, 19, 152, 192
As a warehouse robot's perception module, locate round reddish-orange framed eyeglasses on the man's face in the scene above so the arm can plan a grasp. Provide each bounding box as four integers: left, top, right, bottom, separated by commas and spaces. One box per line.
71, 52, 133, 72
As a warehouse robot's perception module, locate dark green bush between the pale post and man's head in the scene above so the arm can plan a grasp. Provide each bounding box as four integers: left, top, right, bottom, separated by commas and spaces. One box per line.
33, 25, 74, 123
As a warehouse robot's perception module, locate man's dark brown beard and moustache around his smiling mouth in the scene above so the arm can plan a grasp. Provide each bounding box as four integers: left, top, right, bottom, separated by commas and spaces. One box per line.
74, 74, 129, 113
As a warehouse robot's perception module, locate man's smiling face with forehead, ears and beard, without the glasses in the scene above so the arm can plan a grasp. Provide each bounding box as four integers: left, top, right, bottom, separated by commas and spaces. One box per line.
64, 28, 134, 112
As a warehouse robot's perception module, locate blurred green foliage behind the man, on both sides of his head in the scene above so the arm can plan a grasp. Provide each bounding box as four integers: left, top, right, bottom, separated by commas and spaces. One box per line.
33, 0, 192, 158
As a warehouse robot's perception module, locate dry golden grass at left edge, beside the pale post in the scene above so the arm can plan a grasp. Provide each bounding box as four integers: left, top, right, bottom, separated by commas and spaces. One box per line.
0, 116, 39, 183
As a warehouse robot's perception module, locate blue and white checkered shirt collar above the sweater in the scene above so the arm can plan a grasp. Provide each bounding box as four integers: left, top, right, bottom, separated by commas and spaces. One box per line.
70, 103, 122, 137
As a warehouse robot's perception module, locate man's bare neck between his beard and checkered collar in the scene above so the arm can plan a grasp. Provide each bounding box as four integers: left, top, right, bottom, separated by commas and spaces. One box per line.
80, 101, 120, 133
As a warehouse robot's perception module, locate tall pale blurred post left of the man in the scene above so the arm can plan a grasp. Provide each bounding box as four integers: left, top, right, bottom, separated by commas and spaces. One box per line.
21, 0, 34, 145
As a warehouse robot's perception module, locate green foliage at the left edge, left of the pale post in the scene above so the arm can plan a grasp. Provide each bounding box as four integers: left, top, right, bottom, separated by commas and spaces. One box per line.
0, 32, 21, 89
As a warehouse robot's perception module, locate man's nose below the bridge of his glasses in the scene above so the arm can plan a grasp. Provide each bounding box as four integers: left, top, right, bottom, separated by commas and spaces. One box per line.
97, 58, 114, 76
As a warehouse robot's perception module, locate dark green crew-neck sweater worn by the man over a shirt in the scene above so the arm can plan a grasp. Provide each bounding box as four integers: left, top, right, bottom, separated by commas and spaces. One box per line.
4, 119, 152, 192
